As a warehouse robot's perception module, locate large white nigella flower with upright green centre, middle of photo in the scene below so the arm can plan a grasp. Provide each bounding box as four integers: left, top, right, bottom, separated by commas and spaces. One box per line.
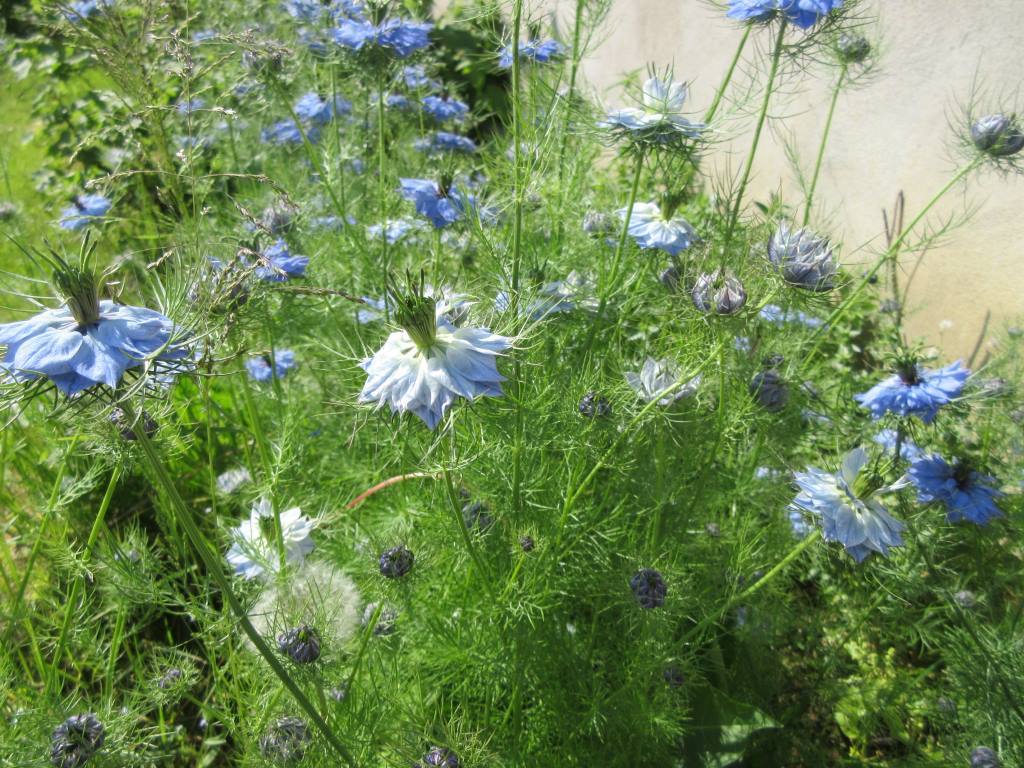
359, 285, 512, 429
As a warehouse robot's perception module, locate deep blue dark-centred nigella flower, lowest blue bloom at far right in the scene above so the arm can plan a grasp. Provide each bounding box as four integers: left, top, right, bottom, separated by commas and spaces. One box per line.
907, 454, 1002, 525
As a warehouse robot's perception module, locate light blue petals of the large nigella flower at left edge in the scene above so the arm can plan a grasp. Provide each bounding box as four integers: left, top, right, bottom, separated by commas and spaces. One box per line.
0, 301, 189, 395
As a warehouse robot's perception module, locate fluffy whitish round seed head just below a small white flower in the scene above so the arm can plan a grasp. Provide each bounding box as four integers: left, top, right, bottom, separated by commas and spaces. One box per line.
249, 560, 361, 648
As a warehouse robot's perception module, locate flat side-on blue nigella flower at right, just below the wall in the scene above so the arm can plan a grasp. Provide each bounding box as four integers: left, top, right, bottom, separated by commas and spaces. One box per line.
853, 360, 971, 424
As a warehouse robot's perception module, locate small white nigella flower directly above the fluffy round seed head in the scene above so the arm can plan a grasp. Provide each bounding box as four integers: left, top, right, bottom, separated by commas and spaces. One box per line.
227, 499, 316, 579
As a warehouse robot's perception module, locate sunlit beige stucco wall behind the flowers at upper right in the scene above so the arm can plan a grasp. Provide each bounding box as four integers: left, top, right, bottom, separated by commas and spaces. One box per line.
438, 0, 1024, 355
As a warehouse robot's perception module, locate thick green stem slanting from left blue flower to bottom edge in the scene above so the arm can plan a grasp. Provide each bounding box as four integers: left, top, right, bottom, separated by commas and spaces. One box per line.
121, 402, 356, 766
